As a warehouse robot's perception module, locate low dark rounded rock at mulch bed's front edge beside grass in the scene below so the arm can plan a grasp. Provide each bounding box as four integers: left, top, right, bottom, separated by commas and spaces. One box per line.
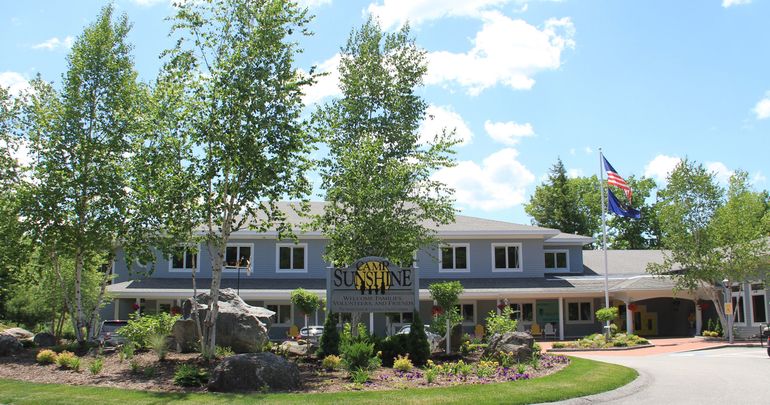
208, 353, 300, 392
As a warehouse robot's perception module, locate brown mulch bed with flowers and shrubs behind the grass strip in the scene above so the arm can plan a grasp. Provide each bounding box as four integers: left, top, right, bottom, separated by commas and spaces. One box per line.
0, 349, 569, 393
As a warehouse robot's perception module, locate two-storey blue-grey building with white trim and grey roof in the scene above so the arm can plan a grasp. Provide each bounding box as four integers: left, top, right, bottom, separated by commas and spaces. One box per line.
102, 203, 769, 339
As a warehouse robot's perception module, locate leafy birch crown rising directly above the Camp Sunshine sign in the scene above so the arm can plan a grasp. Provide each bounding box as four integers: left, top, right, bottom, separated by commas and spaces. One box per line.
314, 19, 454, 265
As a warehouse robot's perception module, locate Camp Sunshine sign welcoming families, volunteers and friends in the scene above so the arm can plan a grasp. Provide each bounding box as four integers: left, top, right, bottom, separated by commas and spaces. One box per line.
327, 256, 419, 312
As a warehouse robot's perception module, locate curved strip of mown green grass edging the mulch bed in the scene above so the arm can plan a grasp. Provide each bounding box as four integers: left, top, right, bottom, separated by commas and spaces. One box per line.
0, 357, 637, 405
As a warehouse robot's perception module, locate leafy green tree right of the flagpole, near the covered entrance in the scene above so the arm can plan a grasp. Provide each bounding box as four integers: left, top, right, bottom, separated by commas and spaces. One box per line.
647, 159, 768, 339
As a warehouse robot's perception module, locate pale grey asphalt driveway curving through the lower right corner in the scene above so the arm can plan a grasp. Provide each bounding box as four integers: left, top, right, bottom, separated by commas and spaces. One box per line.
567, 347, 770, 405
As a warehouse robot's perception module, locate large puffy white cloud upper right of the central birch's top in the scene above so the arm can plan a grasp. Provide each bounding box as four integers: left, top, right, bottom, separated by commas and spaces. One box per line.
425, 12, 575, 95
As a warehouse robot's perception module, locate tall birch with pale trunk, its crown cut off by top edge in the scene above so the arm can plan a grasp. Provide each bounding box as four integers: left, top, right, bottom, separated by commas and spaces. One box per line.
146, 0, 314, 355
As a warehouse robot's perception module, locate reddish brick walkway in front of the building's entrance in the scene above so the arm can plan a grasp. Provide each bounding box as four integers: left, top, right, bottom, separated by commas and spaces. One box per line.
538, 337, 759, 357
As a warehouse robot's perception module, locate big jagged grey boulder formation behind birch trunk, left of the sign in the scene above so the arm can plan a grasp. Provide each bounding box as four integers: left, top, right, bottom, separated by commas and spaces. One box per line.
172, 288, 275, 353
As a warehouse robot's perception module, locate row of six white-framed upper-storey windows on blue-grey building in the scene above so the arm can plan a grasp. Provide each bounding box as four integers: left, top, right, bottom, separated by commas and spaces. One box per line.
171, 243, 569, 272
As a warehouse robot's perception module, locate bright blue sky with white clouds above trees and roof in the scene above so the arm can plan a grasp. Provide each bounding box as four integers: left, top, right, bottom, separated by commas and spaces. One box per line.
0, 0, 770, 224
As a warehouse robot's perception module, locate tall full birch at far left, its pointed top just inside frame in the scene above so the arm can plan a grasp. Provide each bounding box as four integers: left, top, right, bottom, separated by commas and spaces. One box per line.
23, 7, 141, 342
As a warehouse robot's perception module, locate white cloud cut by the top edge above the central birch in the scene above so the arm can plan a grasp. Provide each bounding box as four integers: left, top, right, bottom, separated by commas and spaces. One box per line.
368, 0, 511, 29
